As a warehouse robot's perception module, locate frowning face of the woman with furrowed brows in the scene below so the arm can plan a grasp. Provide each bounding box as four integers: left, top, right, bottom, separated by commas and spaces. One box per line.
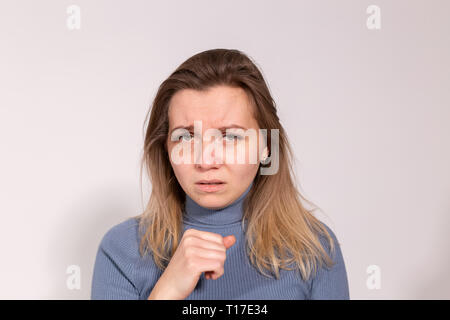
167, 86, 266, 209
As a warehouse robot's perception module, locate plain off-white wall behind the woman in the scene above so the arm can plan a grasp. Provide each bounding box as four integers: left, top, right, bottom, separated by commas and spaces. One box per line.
0, 0, 450, 299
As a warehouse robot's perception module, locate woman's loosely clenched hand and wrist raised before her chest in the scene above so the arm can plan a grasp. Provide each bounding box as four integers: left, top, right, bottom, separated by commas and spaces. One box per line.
148, 229, 236, 300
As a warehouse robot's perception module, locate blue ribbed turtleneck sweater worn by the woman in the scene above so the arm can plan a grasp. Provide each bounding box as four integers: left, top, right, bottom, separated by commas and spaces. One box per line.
91, 183, 350, 300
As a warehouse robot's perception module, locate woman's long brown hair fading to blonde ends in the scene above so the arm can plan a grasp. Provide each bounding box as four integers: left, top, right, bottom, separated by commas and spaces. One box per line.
135, 49, 335, 280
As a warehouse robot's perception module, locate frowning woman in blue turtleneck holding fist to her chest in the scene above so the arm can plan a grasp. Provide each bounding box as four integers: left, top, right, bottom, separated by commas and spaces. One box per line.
91, 49, 349, 299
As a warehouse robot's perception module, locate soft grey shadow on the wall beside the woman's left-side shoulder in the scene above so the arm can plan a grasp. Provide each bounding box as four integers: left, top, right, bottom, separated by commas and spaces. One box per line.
42, 183, 141, 300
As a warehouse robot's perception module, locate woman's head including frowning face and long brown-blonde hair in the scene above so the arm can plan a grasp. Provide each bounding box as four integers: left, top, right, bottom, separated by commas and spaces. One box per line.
139, 49, 333, 278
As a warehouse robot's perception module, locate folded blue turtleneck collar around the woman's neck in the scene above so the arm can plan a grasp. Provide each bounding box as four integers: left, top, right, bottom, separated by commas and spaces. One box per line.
185, 181, 253, 225
